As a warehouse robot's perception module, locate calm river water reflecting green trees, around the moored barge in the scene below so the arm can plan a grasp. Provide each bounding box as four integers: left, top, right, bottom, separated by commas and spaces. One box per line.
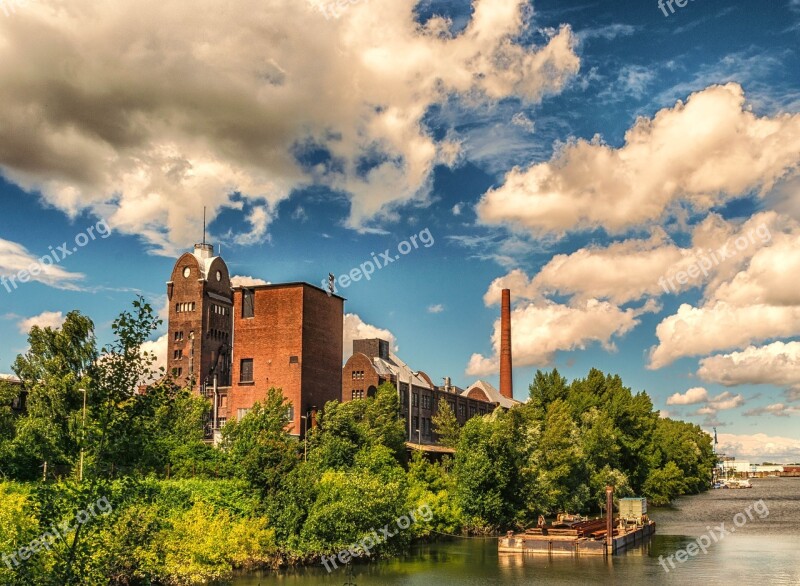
234, 478, 800, 586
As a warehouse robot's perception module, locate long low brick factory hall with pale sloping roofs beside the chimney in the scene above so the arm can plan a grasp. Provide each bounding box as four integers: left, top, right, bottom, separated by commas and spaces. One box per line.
342, 338, 517, 444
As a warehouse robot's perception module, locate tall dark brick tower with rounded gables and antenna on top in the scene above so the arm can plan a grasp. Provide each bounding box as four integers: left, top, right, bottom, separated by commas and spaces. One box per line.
167, 242, 233, 392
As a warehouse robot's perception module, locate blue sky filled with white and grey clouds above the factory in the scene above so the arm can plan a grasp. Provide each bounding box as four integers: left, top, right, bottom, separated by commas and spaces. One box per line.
0, 0, 800, 462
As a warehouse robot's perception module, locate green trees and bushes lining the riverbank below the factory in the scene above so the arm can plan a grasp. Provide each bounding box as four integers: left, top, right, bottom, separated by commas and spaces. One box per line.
0, 300, 713, 586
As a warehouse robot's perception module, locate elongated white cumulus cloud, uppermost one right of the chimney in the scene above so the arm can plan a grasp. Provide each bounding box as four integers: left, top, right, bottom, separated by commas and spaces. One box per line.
477, 83, 800, 233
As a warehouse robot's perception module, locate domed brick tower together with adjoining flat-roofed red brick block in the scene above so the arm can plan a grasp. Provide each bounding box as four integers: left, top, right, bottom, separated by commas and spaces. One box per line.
167, 243, 344, 436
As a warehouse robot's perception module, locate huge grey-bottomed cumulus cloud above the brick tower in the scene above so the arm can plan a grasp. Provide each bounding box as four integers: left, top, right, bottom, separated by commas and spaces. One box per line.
0, 0, 580, 254
